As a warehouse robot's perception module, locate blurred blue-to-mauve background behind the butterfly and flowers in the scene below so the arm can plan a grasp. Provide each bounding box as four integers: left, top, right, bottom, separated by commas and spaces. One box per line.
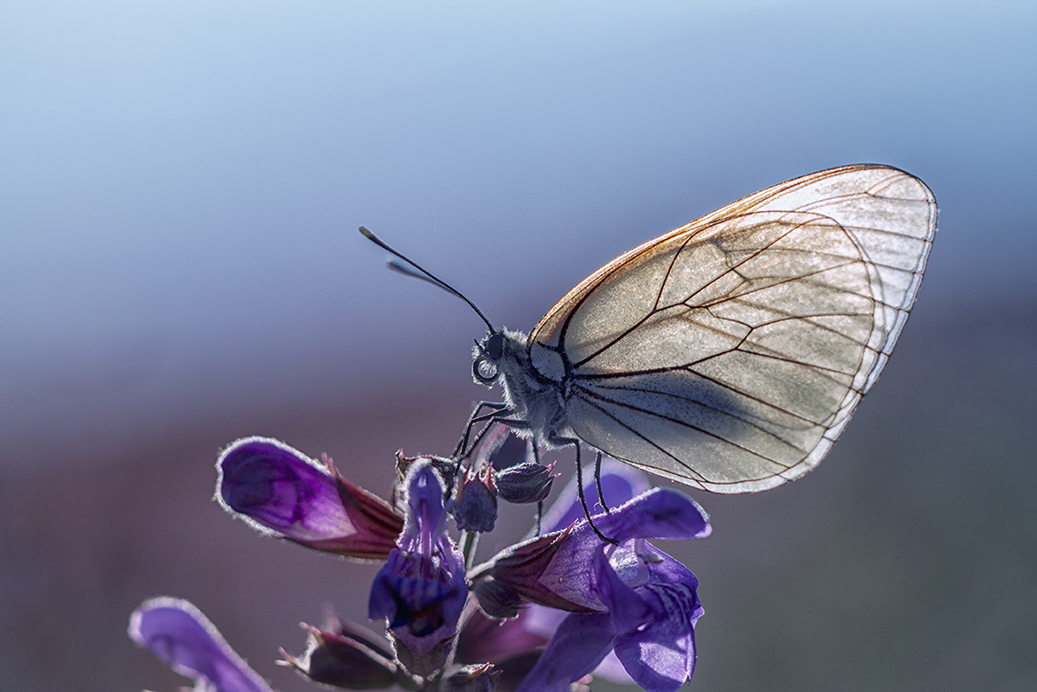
0, 0, 1037, 692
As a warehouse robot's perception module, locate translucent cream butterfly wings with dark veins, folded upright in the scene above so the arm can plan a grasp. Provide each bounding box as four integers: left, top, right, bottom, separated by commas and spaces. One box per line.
529, 165, 936, 493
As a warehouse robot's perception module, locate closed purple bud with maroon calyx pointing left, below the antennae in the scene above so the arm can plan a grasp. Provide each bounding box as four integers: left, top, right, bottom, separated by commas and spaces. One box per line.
216, 437, 403, 559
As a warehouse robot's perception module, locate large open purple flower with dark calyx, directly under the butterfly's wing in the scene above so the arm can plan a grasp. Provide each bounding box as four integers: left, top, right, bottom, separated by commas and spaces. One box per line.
472, 460, 710, 692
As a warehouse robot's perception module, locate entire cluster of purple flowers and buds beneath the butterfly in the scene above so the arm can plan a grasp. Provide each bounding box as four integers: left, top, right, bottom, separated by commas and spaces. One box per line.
131, 437, 710, 692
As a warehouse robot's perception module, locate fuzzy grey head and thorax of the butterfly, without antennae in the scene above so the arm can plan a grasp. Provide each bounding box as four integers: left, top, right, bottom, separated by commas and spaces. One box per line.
472, 329, 572, 447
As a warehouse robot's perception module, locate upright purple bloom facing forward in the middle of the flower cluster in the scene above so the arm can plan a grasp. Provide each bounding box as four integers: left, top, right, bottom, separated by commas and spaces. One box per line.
368, 461, 468, 676
